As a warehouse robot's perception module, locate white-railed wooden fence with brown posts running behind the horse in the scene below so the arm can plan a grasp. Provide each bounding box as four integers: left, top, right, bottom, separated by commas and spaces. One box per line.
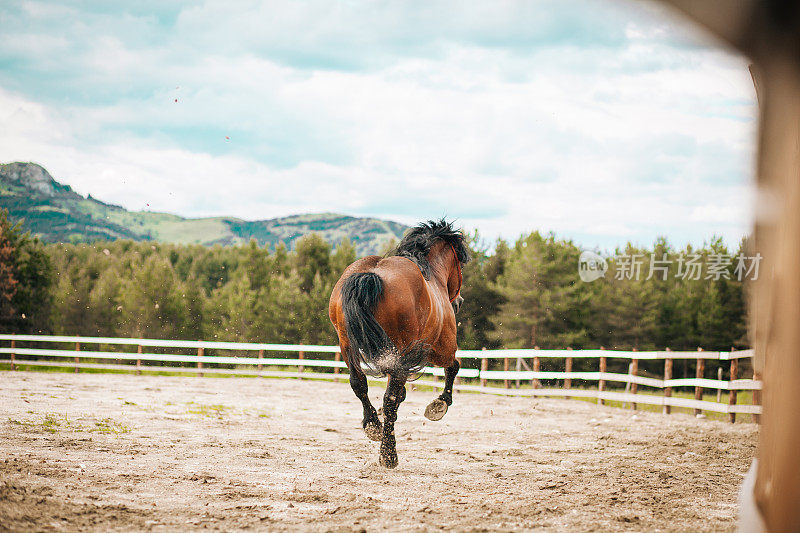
0, 334, 761, 422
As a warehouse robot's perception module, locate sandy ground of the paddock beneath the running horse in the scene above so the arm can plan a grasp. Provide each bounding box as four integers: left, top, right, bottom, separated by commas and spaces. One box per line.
0, 372, 757, 531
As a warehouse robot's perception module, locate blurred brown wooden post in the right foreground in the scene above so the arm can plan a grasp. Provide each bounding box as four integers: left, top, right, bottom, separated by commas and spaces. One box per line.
661, 0, 800, 533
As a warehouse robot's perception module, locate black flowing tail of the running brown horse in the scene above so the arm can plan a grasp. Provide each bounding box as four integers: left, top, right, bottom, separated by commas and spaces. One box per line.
342, 272, 429, 378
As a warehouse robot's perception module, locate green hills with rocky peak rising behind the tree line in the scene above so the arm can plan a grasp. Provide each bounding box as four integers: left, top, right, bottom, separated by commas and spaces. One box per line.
0, 163, 407, 255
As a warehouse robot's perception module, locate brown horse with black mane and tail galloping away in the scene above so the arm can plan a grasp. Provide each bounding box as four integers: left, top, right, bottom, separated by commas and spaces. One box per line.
328, 219, 469, 468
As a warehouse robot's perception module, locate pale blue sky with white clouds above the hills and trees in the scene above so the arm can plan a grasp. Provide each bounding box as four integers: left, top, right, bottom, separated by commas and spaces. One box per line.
0, 0, 756, 248
